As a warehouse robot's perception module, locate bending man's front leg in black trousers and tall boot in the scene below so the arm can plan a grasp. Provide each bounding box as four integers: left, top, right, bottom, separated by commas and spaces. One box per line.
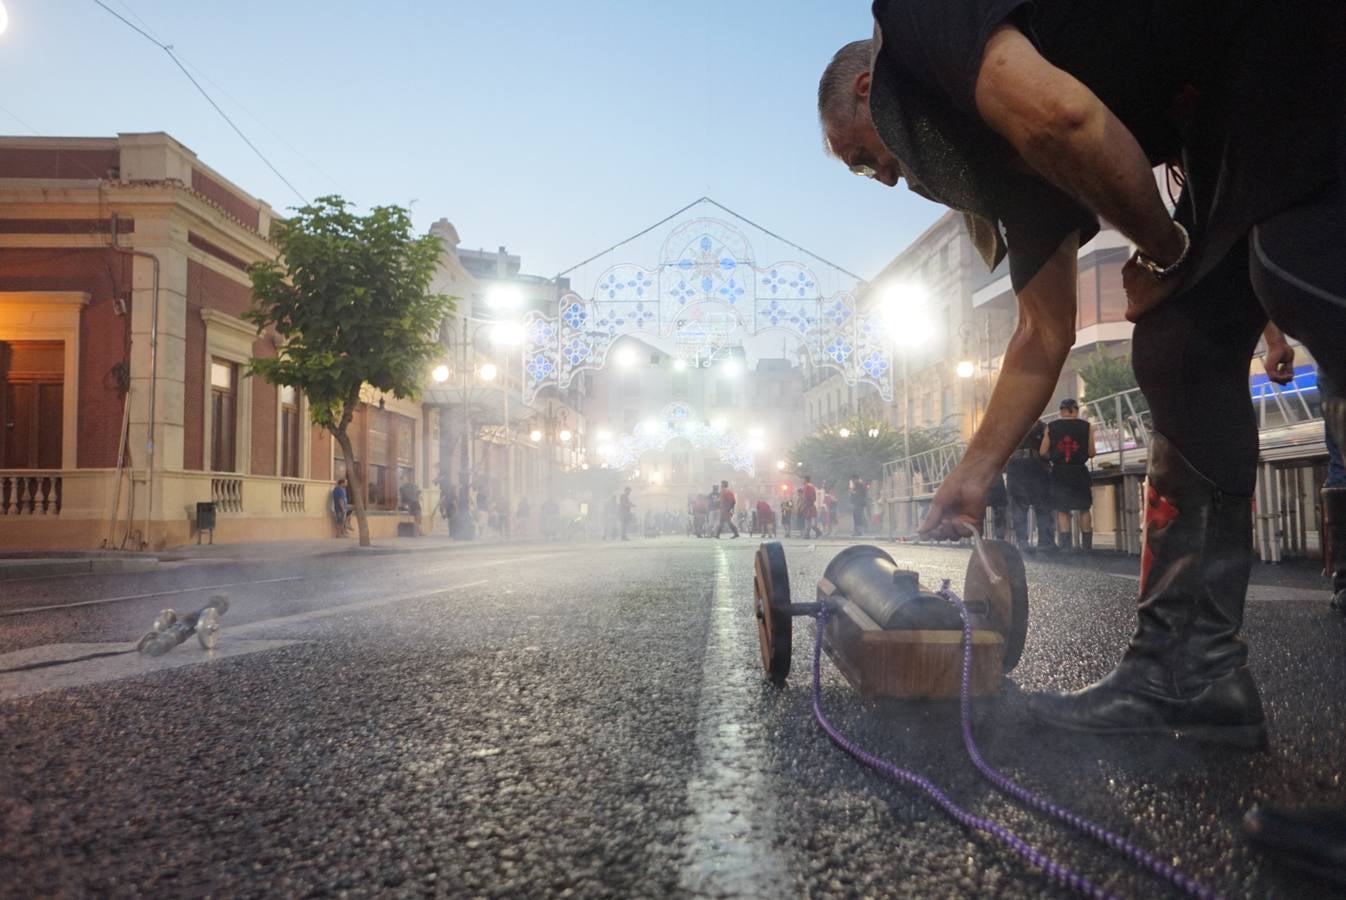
1031, 243, 1267, 747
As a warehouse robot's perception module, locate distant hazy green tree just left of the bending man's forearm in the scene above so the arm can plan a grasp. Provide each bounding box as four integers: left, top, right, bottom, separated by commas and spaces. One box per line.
789, 418, 952, 491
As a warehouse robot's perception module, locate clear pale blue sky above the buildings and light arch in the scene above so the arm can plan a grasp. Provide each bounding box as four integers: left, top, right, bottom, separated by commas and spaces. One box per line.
0, 0, 938, 277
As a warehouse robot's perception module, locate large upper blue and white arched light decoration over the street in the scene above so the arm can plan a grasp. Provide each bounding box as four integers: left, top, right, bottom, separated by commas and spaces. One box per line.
524, 198, 892, 402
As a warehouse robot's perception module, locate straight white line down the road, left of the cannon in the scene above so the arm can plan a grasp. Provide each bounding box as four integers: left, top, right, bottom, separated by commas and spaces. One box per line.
681, 548, 789, 897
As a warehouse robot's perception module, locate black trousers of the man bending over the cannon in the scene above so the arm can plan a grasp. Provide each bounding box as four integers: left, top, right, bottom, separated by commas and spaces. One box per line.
1132, 182, 1346, 496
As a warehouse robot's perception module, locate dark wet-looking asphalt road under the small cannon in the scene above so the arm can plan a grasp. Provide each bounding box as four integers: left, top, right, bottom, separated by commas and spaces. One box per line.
0, 538, 1346, 897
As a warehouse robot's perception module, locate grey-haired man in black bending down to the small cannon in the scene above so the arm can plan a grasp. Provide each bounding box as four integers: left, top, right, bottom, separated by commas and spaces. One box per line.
818, 0, 1346, 877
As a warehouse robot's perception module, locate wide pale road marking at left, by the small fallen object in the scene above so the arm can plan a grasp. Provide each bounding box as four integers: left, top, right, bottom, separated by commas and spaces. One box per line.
0, 578, 487, 702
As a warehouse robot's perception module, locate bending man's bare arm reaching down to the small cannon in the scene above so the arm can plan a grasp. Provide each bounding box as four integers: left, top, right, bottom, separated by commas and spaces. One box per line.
921, 233, 1079, 539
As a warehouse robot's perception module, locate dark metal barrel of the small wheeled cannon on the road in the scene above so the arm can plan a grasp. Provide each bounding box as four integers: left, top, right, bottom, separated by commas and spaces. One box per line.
822, 546, 962, 631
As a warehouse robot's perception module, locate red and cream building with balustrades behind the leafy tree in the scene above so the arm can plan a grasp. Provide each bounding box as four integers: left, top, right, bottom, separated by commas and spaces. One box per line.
0, 133, 437, 549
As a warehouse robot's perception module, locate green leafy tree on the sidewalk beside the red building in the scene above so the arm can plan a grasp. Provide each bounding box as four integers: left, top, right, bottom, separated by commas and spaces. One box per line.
244, 196, 455, 546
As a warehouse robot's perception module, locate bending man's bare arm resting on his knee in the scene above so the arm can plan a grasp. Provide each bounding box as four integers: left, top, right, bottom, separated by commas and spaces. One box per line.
975, 26, 1184, 265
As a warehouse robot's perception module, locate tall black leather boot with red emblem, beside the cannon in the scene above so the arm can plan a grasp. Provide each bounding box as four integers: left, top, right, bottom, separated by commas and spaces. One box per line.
1028, 435, 1267, 747
